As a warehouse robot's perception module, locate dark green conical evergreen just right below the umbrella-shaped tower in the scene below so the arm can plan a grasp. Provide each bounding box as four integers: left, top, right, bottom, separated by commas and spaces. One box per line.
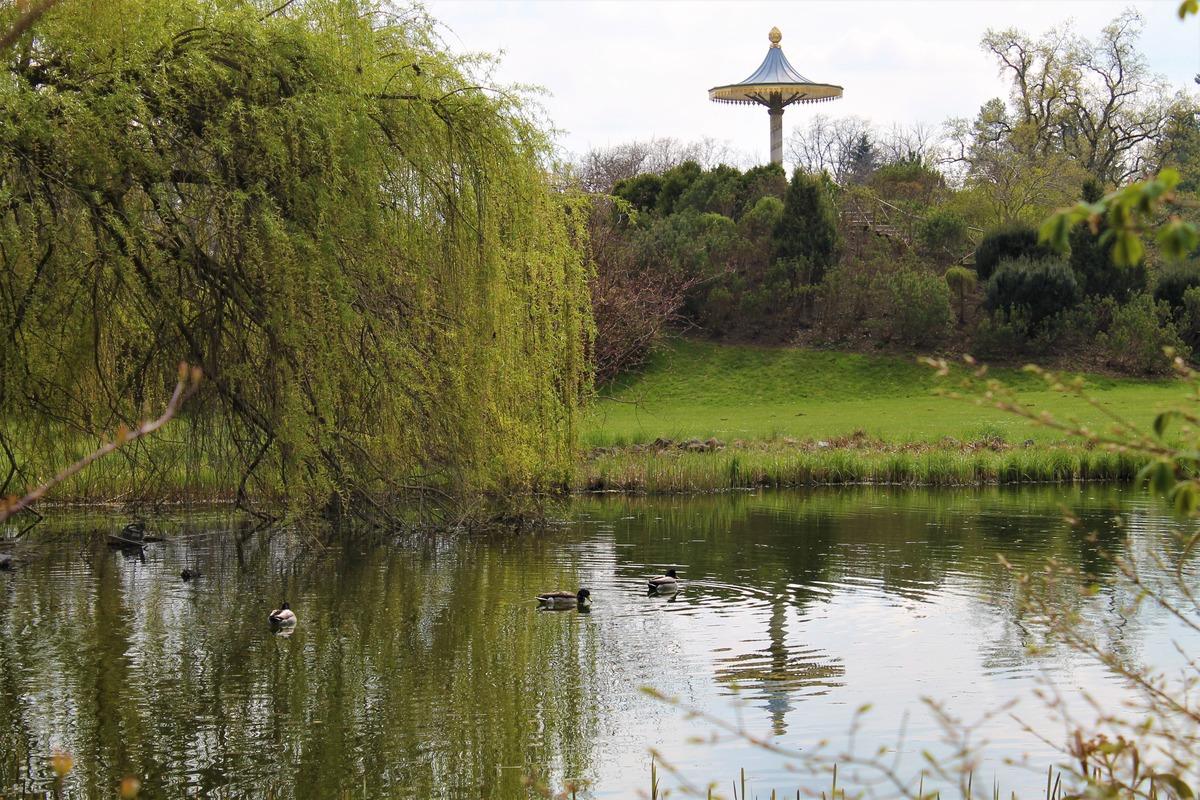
772, 169, 841, 283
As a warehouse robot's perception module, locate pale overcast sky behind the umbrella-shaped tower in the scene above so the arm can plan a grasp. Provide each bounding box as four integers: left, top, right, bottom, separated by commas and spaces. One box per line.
426, 0, 1200, 161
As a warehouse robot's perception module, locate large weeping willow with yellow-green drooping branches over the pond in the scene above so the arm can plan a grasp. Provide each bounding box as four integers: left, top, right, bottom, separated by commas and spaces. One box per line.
0, 0, 590, 520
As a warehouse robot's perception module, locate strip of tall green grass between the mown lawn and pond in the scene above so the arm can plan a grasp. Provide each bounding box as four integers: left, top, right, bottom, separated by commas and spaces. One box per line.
575, 435, 1145, 494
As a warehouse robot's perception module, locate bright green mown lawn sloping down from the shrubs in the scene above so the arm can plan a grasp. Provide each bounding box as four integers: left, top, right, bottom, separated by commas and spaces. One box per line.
582, 341, 1187, 447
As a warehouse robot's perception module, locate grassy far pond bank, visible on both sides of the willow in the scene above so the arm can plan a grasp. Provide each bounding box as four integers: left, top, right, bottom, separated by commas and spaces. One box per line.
2, 434, 1145, 510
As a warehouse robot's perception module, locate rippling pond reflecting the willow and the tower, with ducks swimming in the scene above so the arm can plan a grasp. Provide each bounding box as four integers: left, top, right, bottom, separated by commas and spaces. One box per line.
0, 487, 1196, 798
